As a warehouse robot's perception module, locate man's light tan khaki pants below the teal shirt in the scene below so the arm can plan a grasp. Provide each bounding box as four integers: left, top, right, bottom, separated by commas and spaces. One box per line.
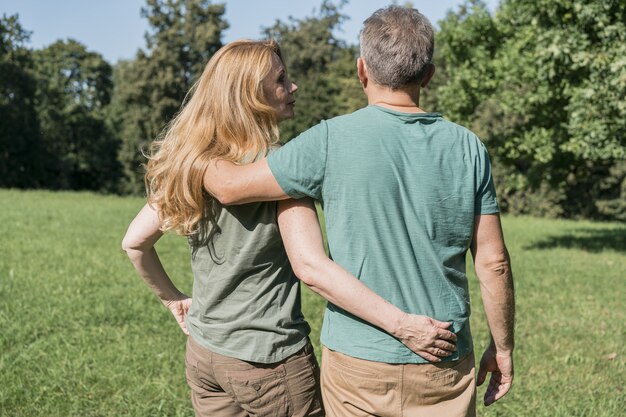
322, 348, 476, 417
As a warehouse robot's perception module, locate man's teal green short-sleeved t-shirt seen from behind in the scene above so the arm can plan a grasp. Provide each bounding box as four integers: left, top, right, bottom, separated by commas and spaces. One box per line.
268, 106, 498, 363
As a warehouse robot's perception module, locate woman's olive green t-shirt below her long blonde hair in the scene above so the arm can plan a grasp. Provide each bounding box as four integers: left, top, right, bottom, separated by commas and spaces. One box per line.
186, 202, 310, 363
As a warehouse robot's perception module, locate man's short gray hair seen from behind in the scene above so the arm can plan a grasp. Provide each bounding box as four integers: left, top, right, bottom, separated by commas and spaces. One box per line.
360, 6, 435, 89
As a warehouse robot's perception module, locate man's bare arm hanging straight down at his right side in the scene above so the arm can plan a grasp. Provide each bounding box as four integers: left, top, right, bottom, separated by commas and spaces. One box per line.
471, 214, 515, 405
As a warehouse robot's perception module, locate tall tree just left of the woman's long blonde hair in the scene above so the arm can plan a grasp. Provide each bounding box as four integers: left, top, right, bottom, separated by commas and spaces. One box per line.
109, 0, 228, 193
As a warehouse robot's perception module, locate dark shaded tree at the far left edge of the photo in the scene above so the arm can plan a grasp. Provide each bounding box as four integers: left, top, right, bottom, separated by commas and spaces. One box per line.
0, 15, 45, 188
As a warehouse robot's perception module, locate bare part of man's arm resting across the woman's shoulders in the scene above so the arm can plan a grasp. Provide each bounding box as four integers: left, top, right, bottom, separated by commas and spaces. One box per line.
203, 158, 289, 206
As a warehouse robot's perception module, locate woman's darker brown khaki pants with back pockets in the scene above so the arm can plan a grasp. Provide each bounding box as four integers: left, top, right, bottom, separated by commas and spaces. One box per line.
185, 337, 324, 417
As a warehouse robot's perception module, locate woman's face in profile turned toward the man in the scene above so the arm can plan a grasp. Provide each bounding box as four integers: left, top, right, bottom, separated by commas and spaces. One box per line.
263, 54, 298, 121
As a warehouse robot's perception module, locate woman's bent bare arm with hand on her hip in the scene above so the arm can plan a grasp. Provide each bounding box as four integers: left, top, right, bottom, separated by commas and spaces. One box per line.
122, 204, 191, 335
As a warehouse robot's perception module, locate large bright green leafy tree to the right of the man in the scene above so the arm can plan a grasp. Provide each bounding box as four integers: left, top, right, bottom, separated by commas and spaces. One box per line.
436, 0, 626, 219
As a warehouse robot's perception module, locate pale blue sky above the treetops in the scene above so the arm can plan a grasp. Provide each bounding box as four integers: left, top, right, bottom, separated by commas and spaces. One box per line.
0, 0, 498, 63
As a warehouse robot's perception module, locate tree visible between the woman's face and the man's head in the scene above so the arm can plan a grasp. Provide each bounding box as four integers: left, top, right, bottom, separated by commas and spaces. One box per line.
264, 1, 366, 140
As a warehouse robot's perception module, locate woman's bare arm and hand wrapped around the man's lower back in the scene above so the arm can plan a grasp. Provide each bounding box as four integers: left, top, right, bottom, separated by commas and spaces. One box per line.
278, 199, 456, 362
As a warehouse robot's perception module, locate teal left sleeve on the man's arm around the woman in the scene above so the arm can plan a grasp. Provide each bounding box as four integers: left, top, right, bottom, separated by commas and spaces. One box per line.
267, 121, 328, 200
